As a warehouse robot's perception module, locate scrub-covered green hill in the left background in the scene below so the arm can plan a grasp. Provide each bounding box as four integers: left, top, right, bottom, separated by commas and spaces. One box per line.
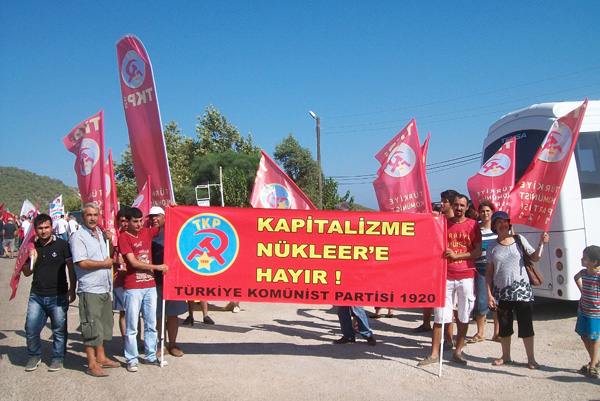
0, 166, 77, 214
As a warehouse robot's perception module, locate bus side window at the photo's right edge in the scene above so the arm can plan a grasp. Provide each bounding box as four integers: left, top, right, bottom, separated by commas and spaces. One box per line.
576, 132, 600, 199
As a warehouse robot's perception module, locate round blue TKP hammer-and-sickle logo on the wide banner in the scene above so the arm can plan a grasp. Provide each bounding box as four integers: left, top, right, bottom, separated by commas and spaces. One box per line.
177, 213, 239, 276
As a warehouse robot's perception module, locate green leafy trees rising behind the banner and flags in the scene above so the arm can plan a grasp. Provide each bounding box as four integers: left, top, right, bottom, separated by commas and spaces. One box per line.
115, 105, 353, 209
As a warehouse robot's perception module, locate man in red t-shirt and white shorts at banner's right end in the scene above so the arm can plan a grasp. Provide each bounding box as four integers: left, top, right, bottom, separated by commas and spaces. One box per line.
419, 194, 481, 366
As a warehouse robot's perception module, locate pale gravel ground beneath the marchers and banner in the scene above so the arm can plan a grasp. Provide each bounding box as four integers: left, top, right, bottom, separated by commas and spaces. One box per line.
0, 255, 600, 400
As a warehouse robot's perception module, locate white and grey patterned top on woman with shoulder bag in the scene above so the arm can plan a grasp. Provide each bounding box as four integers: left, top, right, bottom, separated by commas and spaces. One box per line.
486, 235, 535, 302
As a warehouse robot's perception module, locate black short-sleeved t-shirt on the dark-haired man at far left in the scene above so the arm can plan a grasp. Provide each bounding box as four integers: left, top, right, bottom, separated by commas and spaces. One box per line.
31, 236, 75, 297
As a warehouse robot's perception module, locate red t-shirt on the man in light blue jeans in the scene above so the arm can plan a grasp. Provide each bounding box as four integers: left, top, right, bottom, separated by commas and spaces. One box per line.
119, 227, 160, 290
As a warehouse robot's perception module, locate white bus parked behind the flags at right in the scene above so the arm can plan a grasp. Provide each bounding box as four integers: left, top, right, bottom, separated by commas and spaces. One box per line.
482, 100, 600, 300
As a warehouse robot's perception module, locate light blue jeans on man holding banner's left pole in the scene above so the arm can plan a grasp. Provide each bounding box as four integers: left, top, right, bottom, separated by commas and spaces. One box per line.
123, 287, 158, 363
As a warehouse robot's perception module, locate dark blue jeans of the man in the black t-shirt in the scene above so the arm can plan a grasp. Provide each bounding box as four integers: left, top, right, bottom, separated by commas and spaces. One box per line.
25, 294, 69, 361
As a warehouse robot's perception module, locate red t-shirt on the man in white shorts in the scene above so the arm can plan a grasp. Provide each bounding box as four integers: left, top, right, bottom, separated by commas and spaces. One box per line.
446, 219, 481, 280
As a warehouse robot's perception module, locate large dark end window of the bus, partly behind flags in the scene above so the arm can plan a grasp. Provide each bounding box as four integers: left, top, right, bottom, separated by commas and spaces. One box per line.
483, 130, 548, 183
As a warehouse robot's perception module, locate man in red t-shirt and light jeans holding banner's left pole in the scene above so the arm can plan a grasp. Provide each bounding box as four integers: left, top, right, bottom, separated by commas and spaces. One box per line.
119, 207, 169, 372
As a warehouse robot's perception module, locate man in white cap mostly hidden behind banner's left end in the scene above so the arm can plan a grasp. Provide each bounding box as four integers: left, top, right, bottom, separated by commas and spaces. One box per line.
148, 206, 187, 357
